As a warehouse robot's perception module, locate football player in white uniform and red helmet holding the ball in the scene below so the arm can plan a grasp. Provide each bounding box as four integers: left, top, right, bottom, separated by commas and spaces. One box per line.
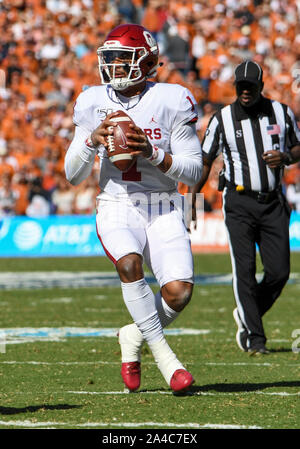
65, 24, 202, 392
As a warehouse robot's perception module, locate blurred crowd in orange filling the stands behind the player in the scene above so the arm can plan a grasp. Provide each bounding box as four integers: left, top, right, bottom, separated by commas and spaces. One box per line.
0, 0, 300, 217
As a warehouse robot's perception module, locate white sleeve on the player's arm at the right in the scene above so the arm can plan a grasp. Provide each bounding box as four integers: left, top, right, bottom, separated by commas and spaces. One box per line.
165, 123, 202, 186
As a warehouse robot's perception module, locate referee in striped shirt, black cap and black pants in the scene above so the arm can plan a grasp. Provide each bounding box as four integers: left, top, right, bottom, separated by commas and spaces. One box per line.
192, 60, 300, 354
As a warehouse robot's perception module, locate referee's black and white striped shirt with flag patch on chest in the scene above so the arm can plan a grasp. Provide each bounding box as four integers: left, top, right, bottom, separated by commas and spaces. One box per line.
202, 97, 300, 192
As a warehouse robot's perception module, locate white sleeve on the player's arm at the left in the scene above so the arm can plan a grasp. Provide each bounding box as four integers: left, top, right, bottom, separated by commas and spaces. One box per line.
65, 126, 97, 185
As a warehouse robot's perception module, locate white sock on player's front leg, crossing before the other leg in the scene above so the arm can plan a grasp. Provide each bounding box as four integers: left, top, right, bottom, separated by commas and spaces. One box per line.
121, 278, 164, 343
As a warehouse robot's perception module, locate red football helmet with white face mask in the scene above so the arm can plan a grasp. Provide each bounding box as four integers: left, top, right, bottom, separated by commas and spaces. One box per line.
97, 24, 159, 90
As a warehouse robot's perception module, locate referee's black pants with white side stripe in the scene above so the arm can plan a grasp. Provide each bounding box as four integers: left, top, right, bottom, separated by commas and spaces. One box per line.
223, 187, 290, 349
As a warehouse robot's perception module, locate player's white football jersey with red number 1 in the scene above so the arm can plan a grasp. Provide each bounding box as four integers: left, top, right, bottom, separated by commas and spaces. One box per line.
73, 82, 197, 196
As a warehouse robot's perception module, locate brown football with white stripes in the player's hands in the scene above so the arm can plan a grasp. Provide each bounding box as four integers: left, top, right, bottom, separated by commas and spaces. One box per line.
107, 111, 136, 172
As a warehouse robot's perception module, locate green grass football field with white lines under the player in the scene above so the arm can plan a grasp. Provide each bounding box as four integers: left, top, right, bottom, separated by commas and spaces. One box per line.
0, 254, 300, 429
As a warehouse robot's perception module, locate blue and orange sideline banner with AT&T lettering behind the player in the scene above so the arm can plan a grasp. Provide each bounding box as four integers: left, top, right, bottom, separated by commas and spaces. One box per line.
0, 212, 300, 257
